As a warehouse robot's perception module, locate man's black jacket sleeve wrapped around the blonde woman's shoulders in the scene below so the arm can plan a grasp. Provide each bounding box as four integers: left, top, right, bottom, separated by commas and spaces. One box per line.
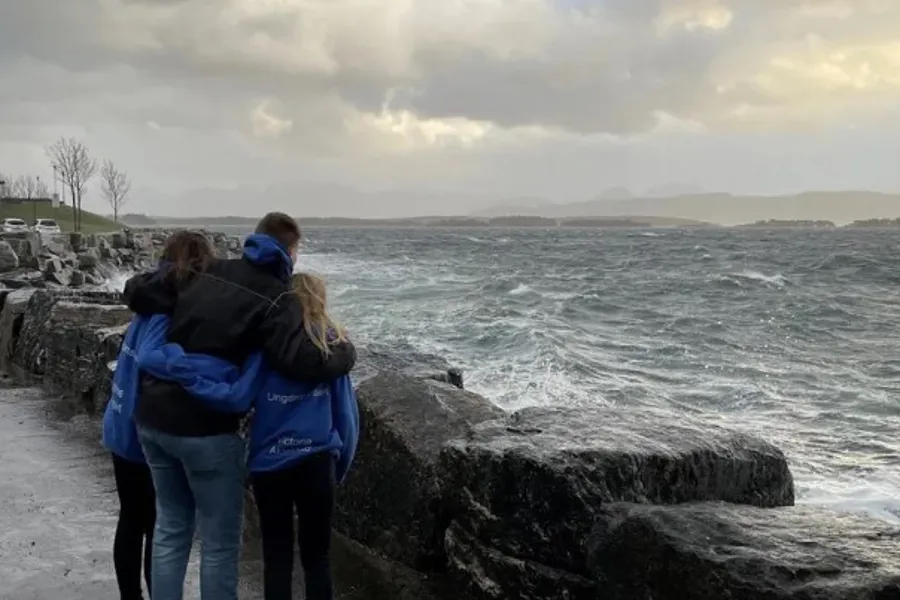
259, 293, 356, 383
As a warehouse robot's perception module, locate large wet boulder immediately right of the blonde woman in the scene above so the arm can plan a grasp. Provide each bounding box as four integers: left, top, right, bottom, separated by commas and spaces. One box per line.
335, 373, 504, 570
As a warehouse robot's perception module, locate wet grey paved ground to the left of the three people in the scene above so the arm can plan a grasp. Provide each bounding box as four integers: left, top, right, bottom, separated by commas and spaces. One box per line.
0, 386, 262, 600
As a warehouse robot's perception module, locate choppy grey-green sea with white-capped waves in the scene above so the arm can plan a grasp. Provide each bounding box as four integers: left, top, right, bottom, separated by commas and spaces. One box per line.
112, 228, 900, 523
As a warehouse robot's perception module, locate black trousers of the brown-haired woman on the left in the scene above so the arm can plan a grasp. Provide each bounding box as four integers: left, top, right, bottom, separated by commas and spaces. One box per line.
113, 454, 156, 600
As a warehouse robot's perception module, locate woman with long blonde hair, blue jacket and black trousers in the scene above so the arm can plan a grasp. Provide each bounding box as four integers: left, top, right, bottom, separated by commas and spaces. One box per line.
249, 273, 359, 600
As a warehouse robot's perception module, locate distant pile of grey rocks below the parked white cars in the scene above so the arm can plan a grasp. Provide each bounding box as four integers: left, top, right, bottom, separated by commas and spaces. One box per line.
0, 229, 241, 289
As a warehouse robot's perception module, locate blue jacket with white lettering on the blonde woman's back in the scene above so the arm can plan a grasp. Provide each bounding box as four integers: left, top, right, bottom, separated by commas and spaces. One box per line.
249, 371, 359, 482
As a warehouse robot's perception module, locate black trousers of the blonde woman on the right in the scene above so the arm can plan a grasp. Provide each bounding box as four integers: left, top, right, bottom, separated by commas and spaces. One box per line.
252, 452, 335, 600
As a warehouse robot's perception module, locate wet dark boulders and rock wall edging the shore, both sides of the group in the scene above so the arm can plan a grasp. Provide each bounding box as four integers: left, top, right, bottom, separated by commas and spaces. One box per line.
0, 246, 900, 600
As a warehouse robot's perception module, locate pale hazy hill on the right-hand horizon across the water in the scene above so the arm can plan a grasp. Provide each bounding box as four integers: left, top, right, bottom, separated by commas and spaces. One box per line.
472, 191, 900, 225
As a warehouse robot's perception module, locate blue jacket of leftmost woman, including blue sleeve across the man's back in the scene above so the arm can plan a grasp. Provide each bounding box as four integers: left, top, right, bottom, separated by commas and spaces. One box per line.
103, 315, 253, 462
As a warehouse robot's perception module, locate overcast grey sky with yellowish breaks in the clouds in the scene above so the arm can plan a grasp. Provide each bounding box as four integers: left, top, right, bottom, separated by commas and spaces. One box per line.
0, 0, 900, 214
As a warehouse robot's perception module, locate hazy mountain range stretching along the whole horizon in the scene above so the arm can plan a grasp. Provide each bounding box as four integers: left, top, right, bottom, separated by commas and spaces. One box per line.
123, 181, 900, 225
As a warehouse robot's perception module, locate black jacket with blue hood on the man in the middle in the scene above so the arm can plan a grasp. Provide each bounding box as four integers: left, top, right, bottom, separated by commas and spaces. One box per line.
124, 236, 356, 437
